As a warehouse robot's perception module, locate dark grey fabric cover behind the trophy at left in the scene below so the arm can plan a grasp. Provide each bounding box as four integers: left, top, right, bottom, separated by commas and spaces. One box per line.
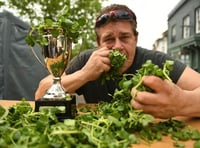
0, 11, 49, 101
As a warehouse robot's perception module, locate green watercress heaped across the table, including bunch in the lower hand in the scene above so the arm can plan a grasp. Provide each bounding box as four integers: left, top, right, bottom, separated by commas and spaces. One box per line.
0, 61, 200, 148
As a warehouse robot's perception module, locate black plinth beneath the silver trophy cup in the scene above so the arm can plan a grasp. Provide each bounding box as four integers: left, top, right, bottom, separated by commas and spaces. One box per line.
35, 95, 77, 121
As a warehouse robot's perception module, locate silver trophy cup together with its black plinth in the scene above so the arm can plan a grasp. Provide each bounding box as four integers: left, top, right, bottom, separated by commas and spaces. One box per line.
28, 29, 76, 120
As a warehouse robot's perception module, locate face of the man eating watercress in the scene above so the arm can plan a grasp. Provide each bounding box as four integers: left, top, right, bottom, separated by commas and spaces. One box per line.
98, 21, 137, 72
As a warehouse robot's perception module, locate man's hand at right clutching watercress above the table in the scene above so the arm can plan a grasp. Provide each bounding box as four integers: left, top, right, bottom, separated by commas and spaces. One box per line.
131, 76, 184, 118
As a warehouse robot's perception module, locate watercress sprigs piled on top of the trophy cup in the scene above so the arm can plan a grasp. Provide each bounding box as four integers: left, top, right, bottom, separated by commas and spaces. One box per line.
26, 16, 85, 47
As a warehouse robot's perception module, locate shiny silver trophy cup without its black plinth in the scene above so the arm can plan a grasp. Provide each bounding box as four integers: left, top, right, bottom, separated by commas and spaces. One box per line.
42, 33, 71, 100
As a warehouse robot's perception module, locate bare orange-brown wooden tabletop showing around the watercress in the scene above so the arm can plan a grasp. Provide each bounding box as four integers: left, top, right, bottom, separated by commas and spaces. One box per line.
0, 100, 200, 148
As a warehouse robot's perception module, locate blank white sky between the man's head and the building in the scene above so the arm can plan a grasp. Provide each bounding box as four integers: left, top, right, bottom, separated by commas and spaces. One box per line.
103, 0, 181, 49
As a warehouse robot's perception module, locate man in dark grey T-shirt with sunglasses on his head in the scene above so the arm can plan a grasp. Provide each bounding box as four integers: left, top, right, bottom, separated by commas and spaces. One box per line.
35, 4, 200, 118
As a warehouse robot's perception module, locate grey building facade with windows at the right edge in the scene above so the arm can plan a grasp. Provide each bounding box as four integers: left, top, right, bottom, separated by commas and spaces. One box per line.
167, 0, 200, 72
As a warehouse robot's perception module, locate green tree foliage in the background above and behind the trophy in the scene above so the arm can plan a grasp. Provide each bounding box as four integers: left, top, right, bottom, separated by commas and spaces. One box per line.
2, 0, 107, 56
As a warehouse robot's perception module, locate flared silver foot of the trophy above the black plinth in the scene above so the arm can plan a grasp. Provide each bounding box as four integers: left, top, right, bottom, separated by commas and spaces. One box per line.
43, 77, 67, 100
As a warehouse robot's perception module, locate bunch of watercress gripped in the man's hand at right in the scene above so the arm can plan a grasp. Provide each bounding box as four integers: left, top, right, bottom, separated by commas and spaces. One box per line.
113, 60, 174, 99
